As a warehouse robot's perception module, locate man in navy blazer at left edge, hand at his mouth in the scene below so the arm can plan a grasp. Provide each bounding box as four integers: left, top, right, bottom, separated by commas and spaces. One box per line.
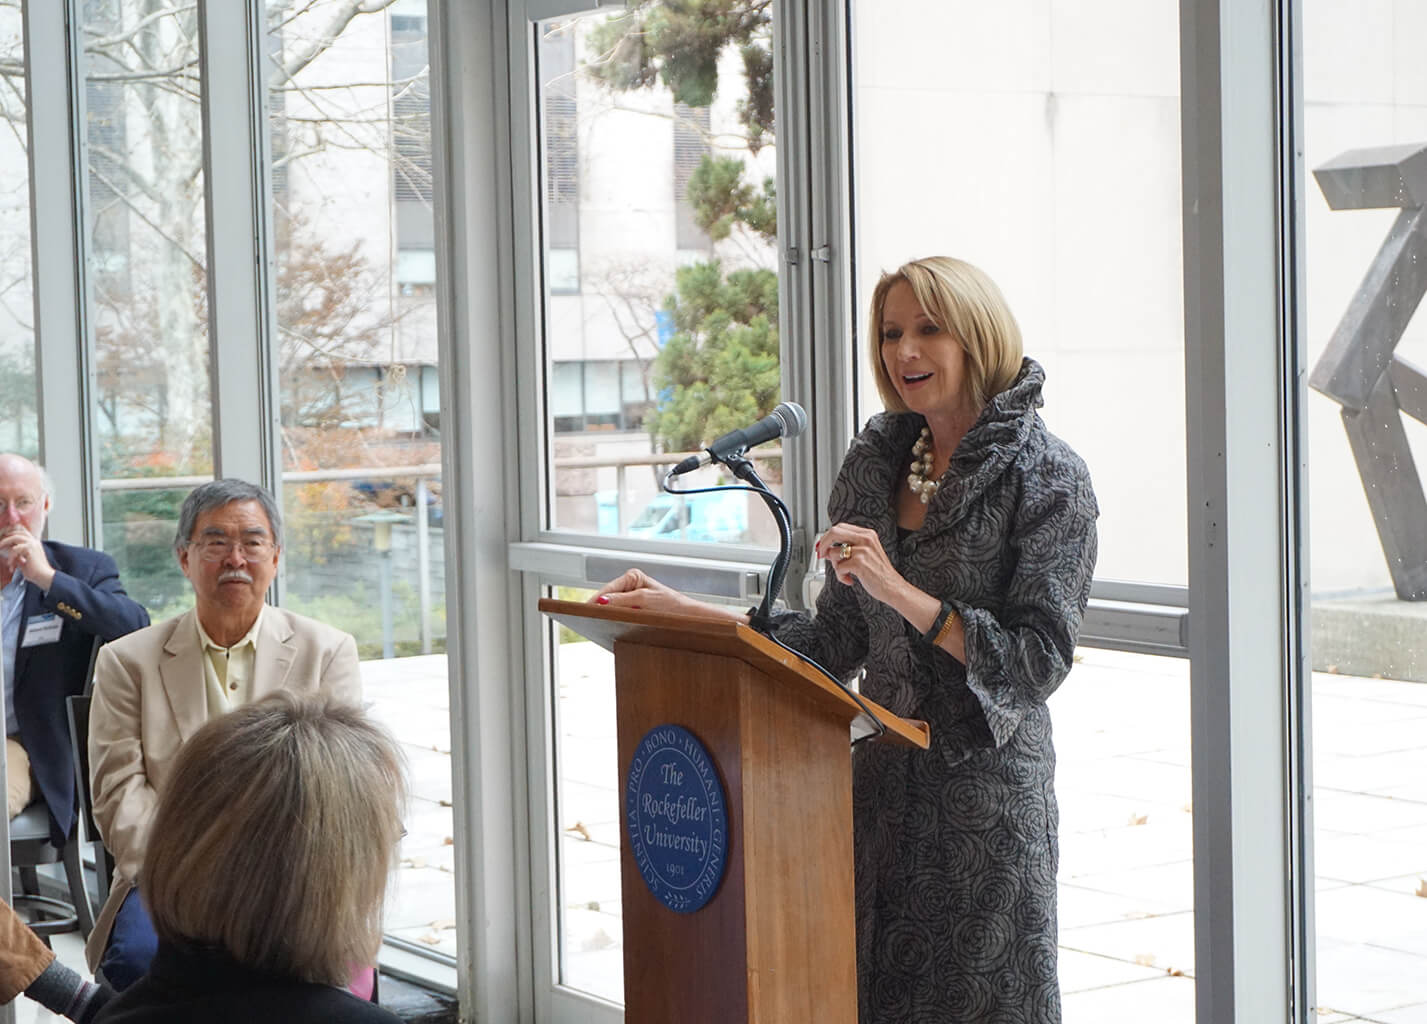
0, 454, 148, 846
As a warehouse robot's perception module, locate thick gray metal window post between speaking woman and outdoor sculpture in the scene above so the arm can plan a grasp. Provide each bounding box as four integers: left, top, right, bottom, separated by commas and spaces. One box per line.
1180, 1, 1311, 1024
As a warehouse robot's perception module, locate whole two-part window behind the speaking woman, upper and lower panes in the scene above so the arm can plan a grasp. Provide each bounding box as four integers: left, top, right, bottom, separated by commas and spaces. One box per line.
850, 0, 1194, 1024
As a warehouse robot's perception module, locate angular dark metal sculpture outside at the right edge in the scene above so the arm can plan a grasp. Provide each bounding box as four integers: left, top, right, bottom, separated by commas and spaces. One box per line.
1309, 143, 1427, 600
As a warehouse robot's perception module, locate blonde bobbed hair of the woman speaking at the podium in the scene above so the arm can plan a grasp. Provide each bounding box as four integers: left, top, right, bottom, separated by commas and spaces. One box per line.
868, 257, 1022, 412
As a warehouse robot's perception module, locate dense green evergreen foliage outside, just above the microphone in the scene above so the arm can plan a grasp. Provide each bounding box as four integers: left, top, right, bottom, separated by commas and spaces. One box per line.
645, 260, 779, 451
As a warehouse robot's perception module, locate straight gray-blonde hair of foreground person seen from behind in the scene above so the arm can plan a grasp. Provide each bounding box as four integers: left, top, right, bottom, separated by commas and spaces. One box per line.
138, 693, 407, 985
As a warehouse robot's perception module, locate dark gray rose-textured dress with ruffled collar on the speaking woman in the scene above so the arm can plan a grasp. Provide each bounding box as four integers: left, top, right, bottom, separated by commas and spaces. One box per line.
776, 359, 1097, 1024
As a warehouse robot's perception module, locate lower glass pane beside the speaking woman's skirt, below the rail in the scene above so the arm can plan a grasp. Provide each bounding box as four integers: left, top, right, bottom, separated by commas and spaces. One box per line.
1050, 647, 1194, 1024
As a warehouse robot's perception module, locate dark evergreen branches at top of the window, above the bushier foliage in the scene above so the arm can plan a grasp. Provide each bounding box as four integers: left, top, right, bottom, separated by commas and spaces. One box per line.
586, 0, 775, 153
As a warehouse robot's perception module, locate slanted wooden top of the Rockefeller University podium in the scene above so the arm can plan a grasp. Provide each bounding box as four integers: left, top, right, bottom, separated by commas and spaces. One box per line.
539, 598, 930, 750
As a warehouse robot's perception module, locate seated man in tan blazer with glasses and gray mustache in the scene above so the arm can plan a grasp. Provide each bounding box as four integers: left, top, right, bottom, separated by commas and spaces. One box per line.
86, 479, 361, 988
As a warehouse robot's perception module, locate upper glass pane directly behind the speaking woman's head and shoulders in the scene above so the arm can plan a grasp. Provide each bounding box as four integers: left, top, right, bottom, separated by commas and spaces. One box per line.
852, 0, 1187, 585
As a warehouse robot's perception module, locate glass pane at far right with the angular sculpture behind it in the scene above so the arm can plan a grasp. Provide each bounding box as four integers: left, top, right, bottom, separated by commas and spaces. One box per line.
1300, 0, 1427, 1021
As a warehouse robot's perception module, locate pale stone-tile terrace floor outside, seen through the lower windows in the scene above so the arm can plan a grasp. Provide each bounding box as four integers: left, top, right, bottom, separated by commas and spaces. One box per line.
30, 643, 1427, 1024
